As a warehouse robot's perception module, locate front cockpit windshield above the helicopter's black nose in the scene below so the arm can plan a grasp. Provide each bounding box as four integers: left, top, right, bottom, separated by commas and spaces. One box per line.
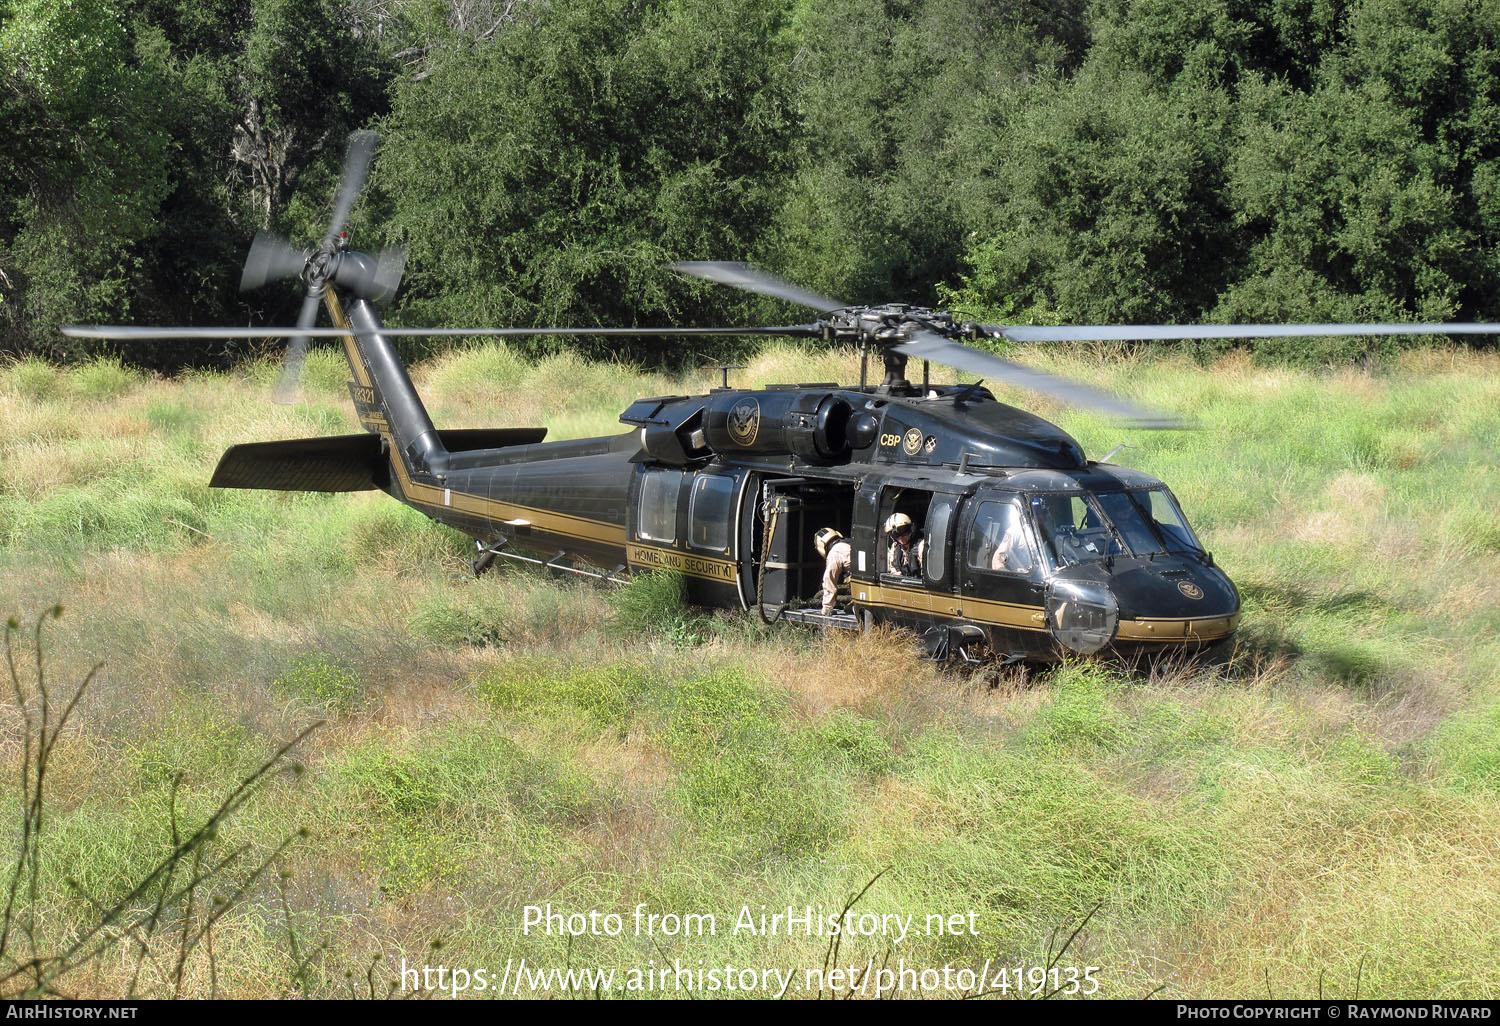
1031, 488, 1203, 570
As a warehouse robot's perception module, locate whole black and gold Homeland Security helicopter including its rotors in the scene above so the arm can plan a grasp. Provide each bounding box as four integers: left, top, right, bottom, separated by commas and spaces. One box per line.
69, 134, 1500, 660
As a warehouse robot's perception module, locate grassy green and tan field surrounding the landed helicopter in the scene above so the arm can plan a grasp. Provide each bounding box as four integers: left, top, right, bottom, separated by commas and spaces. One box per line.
0, 347, 1500, 998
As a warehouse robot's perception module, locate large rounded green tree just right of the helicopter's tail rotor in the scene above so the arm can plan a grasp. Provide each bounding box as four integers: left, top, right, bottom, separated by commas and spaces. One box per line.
374, 0, 797, 357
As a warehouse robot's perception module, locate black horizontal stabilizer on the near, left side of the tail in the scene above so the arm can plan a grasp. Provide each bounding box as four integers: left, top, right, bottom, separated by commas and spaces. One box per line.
209, 434, 390, 492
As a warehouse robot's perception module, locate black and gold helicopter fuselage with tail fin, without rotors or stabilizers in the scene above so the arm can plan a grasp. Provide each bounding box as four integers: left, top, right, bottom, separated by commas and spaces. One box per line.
217, 290, 1239, 660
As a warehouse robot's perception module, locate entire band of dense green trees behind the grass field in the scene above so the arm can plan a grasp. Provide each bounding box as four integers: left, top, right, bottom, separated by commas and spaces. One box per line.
0, 0, 1500, 363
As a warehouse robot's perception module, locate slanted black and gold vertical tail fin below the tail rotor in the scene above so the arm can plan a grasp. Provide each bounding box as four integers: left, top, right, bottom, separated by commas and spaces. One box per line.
323, 285, 449, 477
